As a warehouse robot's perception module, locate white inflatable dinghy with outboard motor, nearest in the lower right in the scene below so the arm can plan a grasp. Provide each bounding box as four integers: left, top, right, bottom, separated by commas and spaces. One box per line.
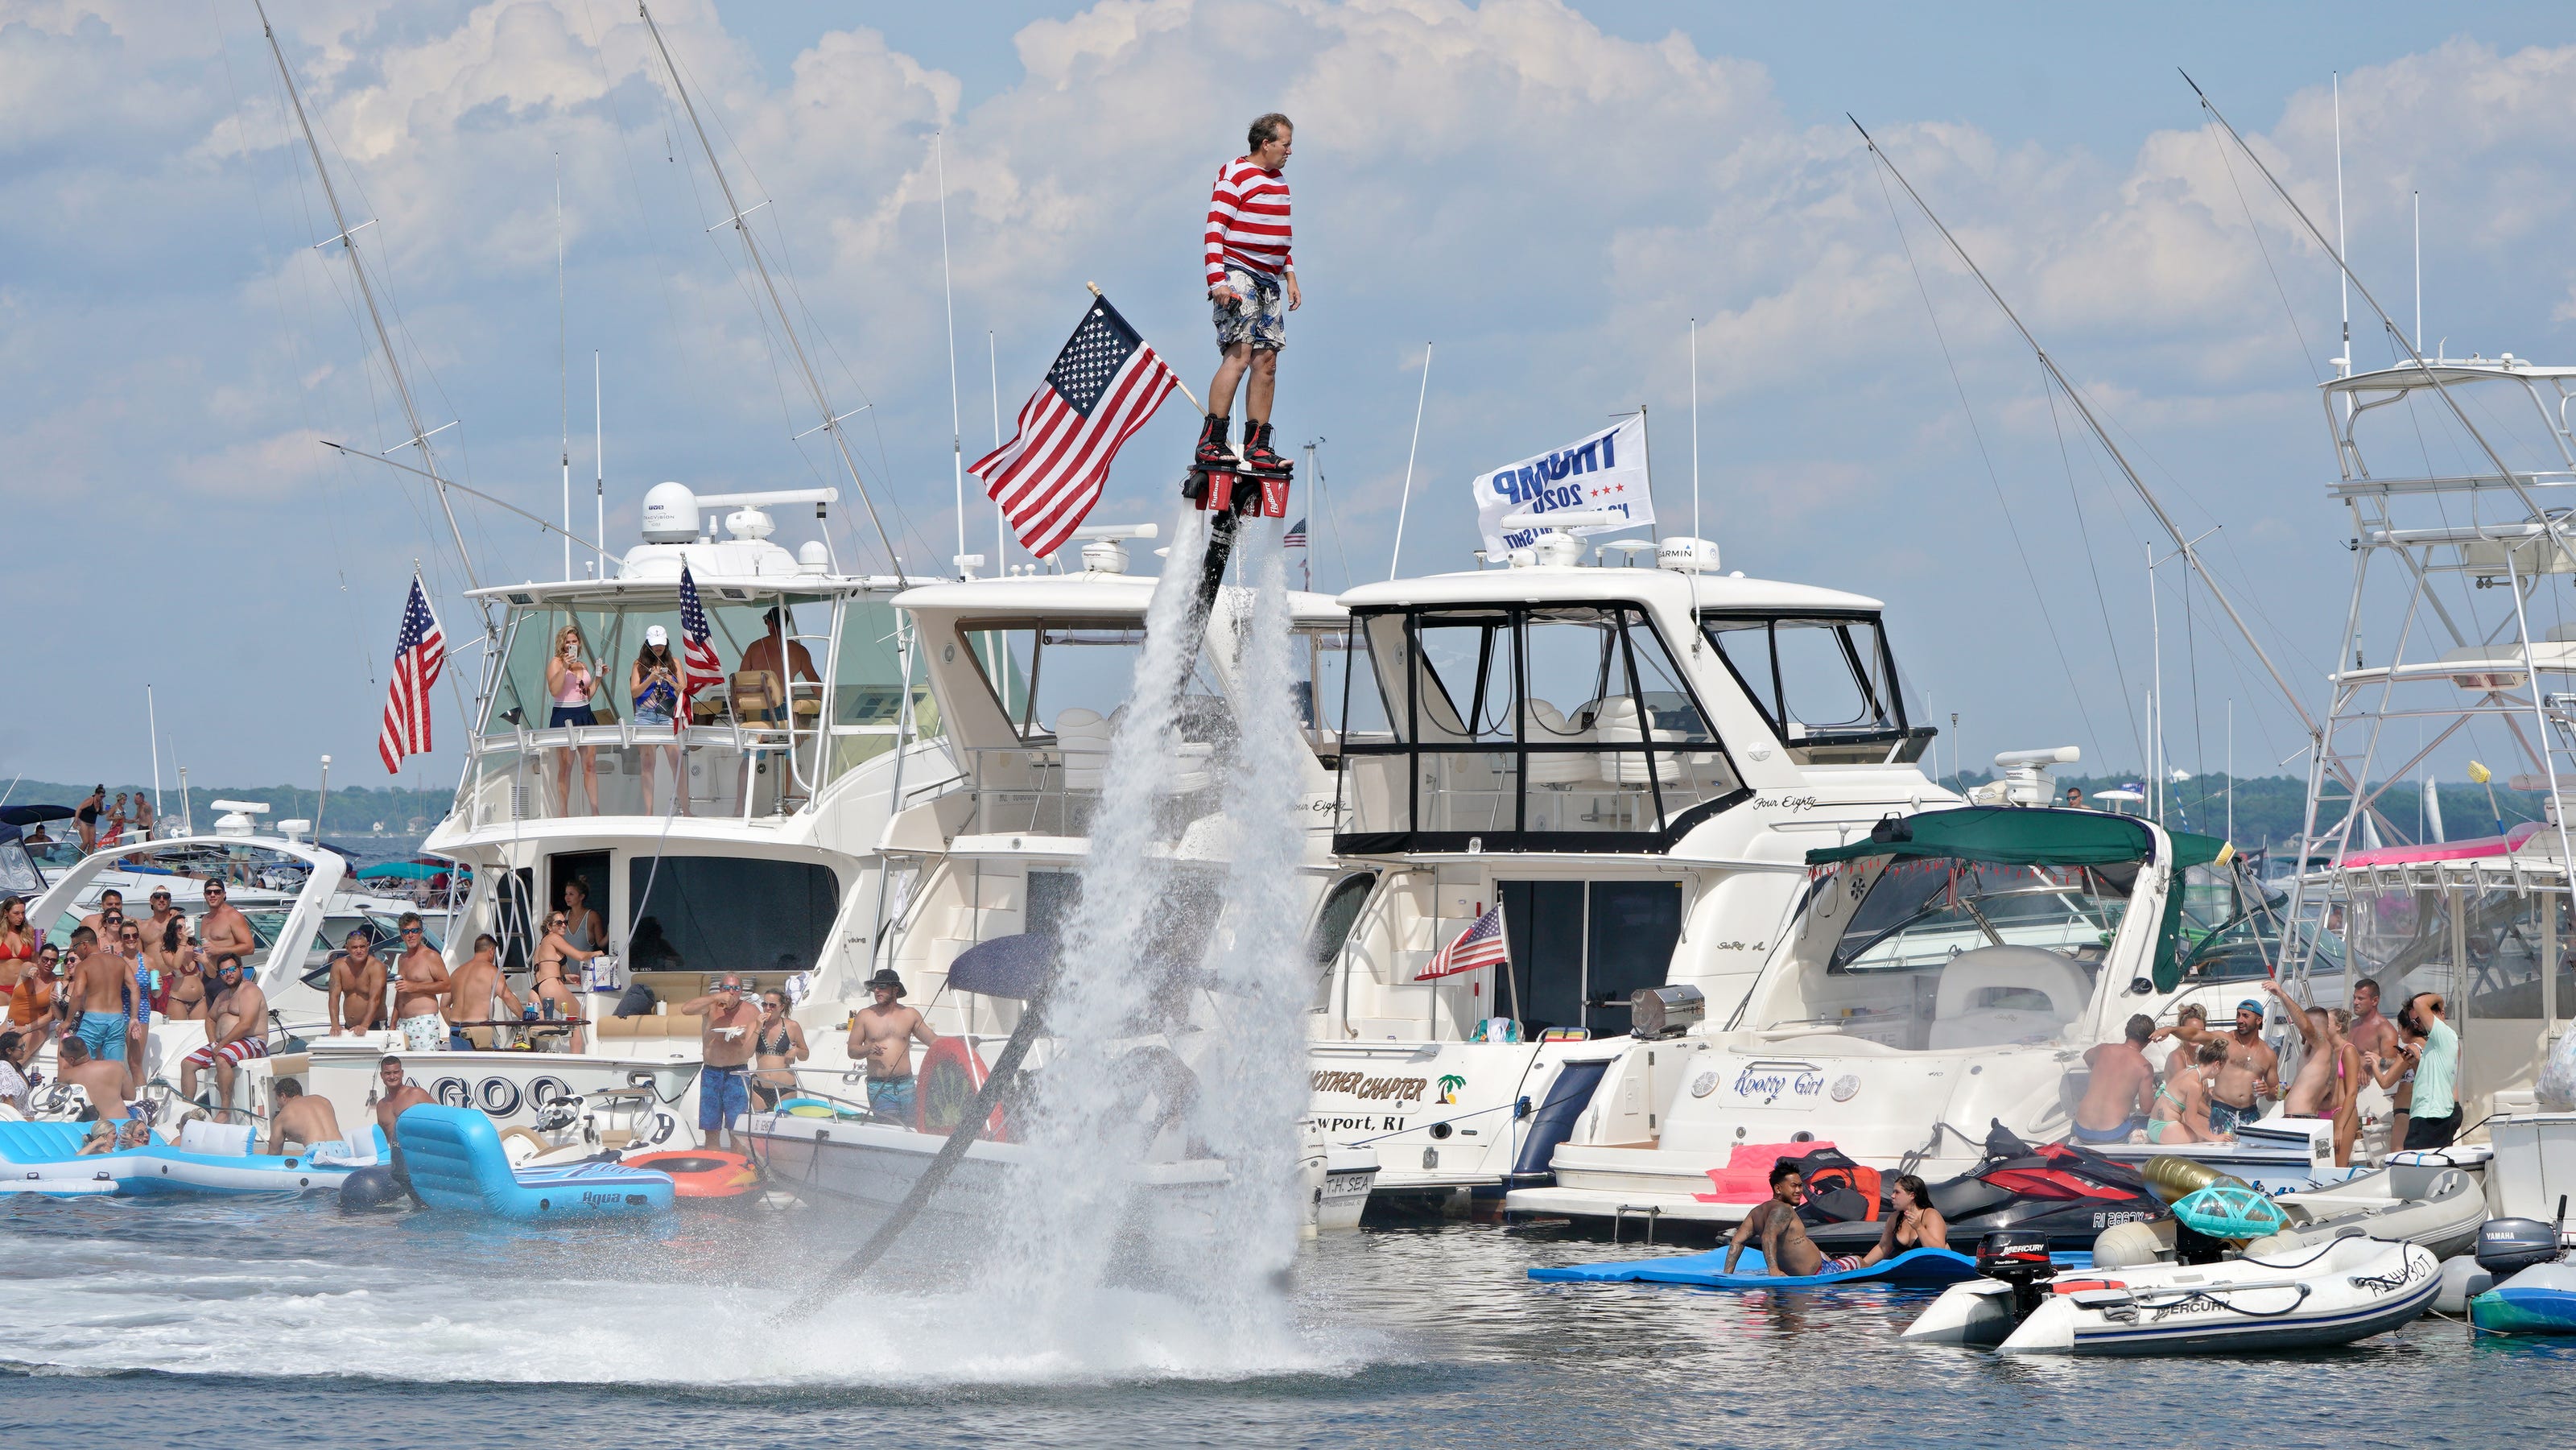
1906, 1236, 2439, 1355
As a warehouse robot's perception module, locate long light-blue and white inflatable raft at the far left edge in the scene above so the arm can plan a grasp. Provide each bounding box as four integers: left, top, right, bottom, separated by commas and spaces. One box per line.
0, 1121, 386, 1195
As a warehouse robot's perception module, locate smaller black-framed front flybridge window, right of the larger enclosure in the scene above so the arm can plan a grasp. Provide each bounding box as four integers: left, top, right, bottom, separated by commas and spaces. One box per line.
1700, 613, 1932, 765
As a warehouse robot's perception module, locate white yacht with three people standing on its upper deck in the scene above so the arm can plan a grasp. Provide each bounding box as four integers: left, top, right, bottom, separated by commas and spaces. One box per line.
277, 481, 956, 1138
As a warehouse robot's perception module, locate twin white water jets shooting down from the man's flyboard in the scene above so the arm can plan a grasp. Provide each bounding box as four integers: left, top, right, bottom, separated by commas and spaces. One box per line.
992, 513, 1303, 1360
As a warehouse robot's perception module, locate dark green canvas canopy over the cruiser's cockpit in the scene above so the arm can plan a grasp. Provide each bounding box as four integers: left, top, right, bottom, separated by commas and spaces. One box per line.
1806, 806, 2233, 992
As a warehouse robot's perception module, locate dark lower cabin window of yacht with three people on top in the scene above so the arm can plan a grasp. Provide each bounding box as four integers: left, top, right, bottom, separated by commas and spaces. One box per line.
626, 855, 840, 973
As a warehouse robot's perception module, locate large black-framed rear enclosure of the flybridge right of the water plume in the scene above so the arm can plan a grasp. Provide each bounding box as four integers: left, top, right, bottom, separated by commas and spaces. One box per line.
1335, 603, 1741, 853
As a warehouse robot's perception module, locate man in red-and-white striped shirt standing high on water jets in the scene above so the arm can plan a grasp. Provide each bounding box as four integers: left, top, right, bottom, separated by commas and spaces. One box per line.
1193, 111, 1306, 477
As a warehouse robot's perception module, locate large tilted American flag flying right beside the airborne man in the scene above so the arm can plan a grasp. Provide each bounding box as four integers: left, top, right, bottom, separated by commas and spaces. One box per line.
966, 296, 1180, 559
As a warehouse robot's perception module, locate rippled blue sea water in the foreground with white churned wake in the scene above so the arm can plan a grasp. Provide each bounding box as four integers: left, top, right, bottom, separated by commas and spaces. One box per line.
0, 1198, 2576, 1450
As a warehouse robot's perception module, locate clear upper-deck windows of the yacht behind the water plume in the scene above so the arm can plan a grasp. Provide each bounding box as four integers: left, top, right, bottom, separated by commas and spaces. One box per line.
961, 621, 1234, 744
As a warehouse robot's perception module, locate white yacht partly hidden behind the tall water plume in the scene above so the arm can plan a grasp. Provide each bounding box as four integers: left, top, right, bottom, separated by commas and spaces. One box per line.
758, 526, 1365, 1203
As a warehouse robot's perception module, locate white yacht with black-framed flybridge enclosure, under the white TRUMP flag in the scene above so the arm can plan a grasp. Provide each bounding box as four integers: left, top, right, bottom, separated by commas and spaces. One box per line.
1309, 531, 1955, 1208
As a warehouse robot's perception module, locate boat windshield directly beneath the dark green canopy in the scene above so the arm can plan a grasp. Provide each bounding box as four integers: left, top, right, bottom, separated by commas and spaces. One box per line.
1762, 857, 2138, 1051
